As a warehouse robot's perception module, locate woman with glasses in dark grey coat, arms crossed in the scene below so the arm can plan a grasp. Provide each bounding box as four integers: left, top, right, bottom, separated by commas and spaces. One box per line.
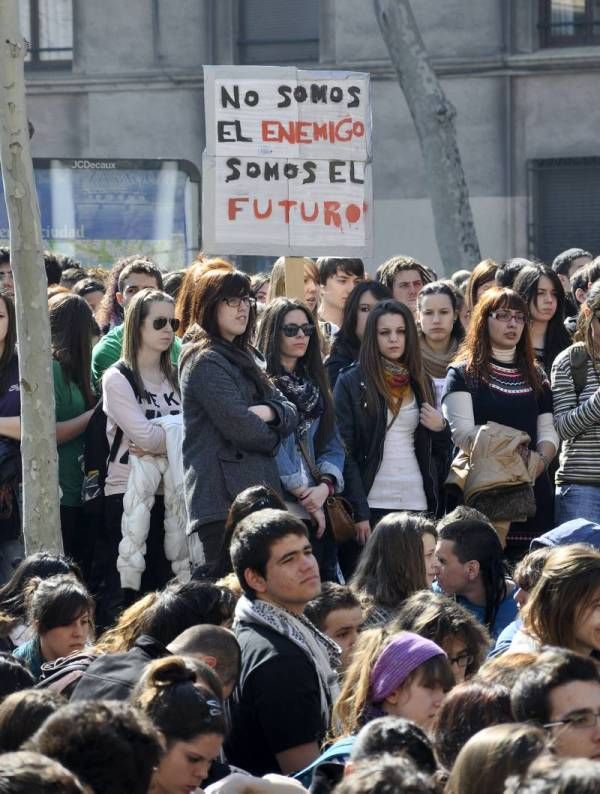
180, 269, 297, 564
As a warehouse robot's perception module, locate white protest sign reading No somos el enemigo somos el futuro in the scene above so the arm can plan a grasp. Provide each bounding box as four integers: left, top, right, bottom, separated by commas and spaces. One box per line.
202, 66, 372, 256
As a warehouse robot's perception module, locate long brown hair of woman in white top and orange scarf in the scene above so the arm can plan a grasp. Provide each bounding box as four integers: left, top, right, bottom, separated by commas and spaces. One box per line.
359, 300, 434, 417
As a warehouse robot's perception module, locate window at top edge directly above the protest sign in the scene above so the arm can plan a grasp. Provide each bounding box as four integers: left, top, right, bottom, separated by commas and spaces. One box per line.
237, 0, 319, 64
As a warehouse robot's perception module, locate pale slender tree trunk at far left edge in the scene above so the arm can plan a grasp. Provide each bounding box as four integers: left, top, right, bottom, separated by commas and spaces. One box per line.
0, 0, 62, 553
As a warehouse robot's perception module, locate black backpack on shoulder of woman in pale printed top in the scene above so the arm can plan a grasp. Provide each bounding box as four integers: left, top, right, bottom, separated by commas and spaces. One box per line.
81, 361, 140, 516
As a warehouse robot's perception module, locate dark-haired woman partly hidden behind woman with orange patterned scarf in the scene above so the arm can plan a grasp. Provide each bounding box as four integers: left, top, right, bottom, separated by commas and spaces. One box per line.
325, 281, 392, 389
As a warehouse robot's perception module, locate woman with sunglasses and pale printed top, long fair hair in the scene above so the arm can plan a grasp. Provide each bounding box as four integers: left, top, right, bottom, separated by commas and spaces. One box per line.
102, 289, 181, 617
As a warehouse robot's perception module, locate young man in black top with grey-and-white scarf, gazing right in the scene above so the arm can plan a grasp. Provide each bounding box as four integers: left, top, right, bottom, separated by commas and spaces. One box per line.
226, 510, 339, 775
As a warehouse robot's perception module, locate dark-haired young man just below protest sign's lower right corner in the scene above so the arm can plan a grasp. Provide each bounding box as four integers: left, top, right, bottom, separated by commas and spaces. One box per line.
317, 256, 365, 330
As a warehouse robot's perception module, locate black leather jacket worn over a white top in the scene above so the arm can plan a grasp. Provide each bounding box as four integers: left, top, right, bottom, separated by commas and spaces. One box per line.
334, 364, 452, 521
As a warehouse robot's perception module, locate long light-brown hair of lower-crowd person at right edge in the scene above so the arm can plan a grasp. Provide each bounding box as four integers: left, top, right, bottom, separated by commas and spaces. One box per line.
521, 543, 600, 651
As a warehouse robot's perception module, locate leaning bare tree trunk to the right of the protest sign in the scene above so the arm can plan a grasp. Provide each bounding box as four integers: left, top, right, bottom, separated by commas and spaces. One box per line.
374, 0, 481, 274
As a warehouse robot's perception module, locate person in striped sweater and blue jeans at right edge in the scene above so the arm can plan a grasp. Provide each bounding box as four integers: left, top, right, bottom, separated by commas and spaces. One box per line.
552, 282, 600, 524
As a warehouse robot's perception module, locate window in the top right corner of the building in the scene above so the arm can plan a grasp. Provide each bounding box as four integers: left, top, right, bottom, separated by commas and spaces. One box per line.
540, 0, 600, 47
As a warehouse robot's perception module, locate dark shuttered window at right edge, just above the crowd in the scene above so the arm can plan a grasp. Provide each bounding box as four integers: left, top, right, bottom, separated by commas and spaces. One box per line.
529, 157, 600, 262
